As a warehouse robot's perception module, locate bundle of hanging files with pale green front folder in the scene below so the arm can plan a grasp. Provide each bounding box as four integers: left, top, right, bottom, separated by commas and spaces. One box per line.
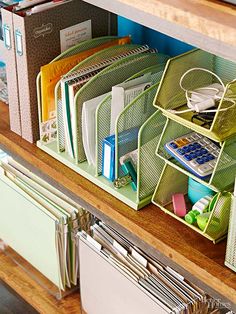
0, 157, 91, 291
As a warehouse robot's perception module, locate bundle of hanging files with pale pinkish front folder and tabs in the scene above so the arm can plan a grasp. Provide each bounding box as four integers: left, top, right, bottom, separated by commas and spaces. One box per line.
78, 222, 206, 314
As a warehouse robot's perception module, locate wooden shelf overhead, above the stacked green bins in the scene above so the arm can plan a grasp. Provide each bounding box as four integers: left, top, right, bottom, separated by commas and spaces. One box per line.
81, 0, 236, 61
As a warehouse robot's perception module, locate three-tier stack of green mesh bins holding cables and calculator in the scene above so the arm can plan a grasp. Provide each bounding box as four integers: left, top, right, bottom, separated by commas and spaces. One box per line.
152, 49, 236, 243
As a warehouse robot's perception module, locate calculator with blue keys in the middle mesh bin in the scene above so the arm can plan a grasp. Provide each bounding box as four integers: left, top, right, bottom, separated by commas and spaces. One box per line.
165, 132, 233, 178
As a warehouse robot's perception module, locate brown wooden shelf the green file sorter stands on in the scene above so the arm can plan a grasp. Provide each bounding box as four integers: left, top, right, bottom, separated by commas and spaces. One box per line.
0, 104, 236, 310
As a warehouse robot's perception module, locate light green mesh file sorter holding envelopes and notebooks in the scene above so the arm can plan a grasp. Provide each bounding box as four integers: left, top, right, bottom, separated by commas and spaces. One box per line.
37, 49, 168, 210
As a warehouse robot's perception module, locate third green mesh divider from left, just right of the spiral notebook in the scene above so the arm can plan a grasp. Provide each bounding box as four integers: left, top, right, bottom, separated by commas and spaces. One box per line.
74, 53, 163, 162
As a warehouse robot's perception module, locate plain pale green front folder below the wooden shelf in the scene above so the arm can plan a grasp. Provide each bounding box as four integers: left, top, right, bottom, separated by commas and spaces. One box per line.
0, 171, 63, 289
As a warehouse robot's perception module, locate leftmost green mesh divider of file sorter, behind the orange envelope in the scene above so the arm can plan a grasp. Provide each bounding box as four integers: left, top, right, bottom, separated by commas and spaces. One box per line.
36, 36, 118, 147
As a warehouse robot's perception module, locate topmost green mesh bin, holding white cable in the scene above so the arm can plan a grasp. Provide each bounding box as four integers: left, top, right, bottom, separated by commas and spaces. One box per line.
154, 49, 236, 142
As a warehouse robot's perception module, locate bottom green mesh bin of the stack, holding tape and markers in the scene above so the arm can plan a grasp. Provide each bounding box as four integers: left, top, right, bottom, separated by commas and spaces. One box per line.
152, 164, 232, 243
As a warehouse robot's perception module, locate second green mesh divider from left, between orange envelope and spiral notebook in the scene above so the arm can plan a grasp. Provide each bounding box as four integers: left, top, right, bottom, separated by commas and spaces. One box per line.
55, 43, 147, 156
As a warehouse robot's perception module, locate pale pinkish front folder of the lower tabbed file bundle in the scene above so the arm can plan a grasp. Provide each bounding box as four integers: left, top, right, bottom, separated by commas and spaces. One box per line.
79, 237, 168, 314
